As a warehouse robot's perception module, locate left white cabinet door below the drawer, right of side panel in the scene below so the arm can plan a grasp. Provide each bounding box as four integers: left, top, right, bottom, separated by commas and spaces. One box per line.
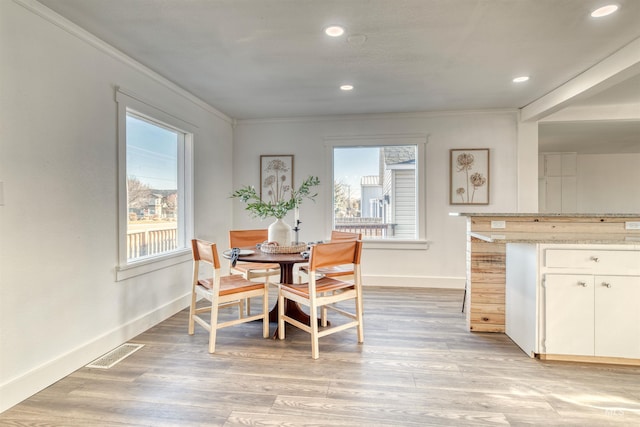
543, 274, 594, 356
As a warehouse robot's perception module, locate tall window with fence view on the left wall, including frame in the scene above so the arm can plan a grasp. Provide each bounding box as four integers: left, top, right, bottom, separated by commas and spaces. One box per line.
116, 90, 193, 278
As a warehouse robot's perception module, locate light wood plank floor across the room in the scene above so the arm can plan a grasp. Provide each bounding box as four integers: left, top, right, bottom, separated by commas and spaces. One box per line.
0, 287, 640, 427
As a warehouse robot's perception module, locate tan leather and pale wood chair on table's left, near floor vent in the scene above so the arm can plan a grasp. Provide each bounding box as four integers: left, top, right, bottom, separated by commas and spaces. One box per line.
189, 239, 269, 353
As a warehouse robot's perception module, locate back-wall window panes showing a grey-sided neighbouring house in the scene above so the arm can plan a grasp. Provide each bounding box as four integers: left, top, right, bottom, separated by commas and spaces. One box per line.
329, 137, 426, 241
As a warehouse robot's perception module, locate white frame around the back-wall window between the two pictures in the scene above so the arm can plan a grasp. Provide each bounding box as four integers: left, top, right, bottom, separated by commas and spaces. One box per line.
324, 135, 429, 250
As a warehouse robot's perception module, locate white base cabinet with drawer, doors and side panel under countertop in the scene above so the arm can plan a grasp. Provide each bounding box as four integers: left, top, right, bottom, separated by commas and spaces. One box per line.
505, 243, 640, 363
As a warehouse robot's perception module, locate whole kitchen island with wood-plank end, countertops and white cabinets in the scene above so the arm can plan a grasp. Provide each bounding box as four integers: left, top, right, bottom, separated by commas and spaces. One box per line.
464, 214, 640, 365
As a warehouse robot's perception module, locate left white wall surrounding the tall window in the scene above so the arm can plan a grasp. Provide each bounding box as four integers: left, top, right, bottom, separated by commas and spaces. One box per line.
0, 0, 232, 411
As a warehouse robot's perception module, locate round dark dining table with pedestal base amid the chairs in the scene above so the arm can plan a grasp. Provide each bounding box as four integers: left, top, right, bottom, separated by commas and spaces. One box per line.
238, 246, 320, 325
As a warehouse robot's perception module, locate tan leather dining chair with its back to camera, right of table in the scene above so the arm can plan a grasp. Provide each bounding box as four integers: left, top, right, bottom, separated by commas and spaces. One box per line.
278, 240, 364, 359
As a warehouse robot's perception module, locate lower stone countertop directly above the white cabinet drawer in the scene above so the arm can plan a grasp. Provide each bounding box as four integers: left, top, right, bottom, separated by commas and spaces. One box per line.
470, 230, 640, 246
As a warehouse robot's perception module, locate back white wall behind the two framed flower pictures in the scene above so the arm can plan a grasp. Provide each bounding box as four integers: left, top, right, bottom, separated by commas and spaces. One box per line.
233, 111, 524, 287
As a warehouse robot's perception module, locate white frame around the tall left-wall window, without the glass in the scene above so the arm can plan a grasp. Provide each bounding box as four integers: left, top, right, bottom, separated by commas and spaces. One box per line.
116, 88, 197, 281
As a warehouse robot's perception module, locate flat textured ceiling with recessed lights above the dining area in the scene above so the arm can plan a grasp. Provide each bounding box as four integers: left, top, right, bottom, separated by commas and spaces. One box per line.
39, 0, 640, 152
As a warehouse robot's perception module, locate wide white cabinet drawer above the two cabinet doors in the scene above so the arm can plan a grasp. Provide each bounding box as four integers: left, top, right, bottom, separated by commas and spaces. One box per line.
544, 249, 640, 275
